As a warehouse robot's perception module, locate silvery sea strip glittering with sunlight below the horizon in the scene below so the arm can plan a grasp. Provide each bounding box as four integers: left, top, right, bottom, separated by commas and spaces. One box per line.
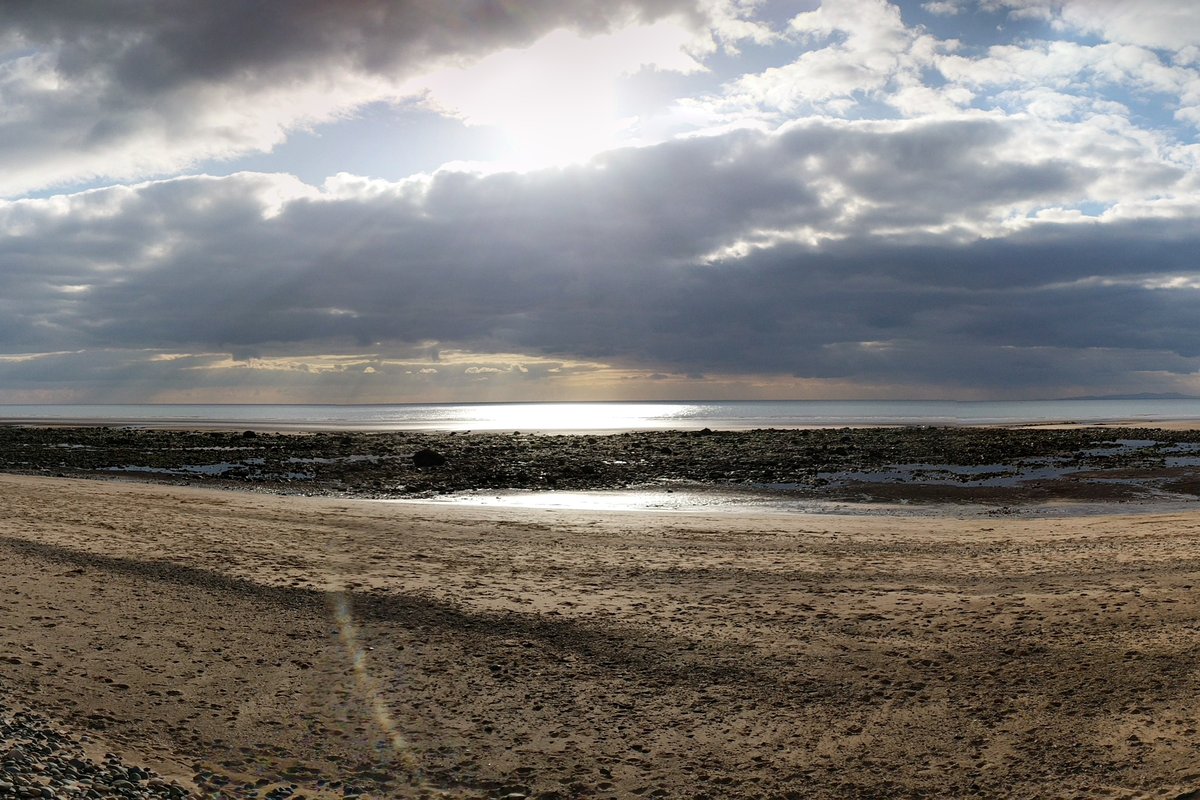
0, 398, 1200, 433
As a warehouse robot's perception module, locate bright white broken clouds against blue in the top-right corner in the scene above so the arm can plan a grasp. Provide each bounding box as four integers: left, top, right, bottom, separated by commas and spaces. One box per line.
692, 0, 1200, 136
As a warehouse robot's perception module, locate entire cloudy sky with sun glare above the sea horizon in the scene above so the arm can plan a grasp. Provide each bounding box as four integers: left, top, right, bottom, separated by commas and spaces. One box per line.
0, 0, 1200, 403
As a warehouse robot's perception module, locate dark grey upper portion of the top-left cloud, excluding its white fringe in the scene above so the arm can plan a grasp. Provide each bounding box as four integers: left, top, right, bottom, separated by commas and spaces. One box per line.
0, 0, 695, 89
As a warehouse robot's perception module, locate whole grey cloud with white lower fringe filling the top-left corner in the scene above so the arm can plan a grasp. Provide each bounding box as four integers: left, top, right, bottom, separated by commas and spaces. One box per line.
0, 0, 704, 197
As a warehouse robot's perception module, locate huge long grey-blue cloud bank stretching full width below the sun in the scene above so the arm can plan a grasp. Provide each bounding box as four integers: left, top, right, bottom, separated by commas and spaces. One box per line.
0, 120, 1200, 392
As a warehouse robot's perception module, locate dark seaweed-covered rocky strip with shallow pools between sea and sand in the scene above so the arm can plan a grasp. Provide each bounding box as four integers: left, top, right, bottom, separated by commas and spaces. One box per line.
0, 427, 1200, 504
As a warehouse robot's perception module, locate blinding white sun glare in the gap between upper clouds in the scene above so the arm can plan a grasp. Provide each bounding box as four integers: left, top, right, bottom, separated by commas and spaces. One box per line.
410, 19, 704, 169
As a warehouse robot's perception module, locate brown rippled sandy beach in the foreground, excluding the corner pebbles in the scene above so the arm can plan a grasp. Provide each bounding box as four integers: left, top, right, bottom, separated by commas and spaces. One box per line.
0, 476, 1200, 799
